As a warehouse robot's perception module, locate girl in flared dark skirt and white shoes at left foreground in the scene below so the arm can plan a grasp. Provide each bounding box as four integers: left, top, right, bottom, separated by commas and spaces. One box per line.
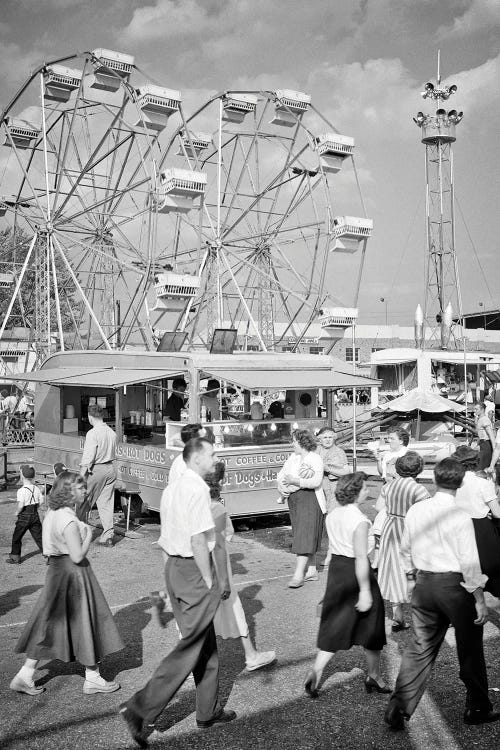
10, 471, 124, 695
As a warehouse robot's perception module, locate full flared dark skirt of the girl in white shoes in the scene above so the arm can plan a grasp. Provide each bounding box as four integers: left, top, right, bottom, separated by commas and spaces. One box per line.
15, 555, 124, 666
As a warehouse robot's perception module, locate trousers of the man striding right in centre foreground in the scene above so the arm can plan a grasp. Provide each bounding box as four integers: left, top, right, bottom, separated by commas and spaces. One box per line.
128, 557, 220, 724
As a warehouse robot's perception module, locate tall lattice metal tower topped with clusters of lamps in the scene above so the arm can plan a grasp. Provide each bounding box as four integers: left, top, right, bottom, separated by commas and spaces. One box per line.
413, 53, 463, 349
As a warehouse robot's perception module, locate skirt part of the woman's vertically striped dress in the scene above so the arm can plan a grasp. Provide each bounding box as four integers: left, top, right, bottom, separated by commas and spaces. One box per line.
378, 515, 407, 604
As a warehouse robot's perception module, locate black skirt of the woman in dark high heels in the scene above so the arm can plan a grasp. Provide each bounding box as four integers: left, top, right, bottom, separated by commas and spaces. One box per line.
317, 555, 386, 652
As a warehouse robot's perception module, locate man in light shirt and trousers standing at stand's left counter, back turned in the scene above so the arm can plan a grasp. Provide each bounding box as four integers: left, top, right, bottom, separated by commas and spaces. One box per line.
77, 404, 116, 547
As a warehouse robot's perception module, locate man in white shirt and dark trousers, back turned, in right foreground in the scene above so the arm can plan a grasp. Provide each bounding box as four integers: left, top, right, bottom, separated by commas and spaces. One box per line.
385, 458, 500, 730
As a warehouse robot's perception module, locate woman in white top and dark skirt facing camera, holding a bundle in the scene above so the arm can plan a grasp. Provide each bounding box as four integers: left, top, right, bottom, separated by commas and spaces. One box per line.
278, 430, 326, 589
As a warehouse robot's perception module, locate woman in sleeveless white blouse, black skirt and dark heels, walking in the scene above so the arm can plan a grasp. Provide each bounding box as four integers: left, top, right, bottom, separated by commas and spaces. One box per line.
304, 471, 391, 698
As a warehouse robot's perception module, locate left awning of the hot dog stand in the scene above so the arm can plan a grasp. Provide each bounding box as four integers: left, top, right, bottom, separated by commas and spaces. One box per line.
0, 367, 183, 388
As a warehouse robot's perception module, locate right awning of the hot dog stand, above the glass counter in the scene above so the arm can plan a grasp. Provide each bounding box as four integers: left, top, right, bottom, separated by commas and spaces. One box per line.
205, 368, 380, 391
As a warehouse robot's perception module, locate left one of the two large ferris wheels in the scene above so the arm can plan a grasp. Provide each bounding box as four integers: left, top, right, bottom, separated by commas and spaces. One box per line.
0, 49, 179, 359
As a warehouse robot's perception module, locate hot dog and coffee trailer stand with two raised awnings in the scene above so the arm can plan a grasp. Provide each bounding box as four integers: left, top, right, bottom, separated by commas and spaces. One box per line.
24, 351, 378, 516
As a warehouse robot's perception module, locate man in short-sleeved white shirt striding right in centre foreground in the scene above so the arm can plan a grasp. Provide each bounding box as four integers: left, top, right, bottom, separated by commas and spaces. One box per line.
120, 438, 236, 747
